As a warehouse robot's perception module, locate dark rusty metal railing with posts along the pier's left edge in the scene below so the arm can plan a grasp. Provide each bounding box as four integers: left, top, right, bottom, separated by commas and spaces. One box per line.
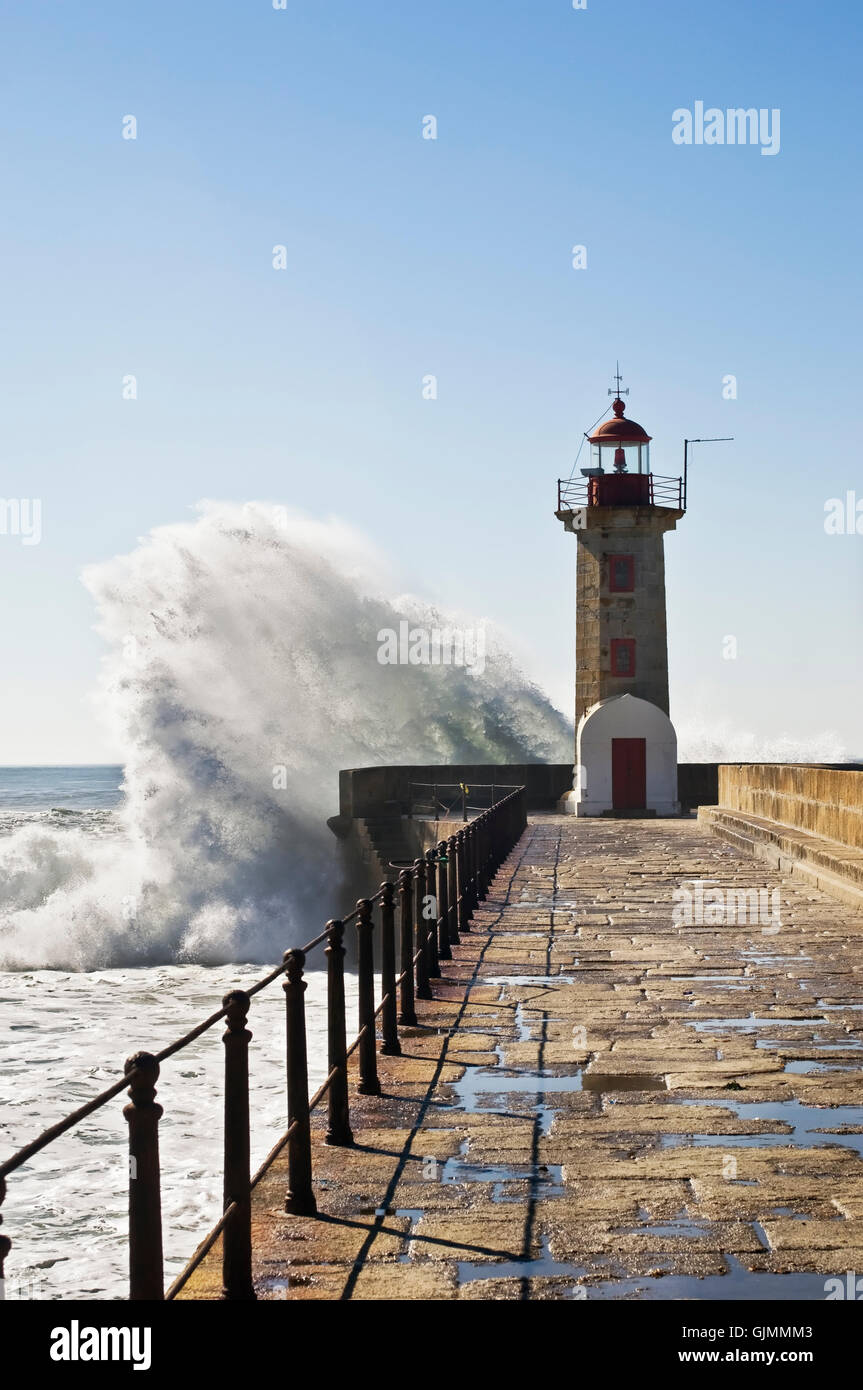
0, 787, 527, 1301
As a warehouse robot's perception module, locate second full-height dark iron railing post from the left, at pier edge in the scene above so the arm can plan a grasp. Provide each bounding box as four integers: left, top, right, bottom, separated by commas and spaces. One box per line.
222, 990, 254, 1298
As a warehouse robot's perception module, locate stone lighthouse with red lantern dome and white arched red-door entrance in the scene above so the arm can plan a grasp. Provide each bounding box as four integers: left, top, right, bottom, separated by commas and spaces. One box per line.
556, 373, 687, 816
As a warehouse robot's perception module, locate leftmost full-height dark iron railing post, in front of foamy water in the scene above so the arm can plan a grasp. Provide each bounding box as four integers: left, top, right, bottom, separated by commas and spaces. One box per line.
122, 1052, 165, 1302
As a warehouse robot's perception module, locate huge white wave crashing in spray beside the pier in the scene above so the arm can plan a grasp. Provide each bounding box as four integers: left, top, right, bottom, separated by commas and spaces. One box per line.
0, 503, 571, 970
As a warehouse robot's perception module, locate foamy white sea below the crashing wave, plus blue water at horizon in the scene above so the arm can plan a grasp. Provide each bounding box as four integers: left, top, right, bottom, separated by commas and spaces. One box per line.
0, 766, 346, 1300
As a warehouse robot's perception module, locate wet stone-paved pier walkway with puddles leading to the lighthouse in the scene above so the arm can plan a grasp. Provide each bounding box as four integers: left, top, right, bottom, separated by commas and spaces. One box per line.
181, 816, 863, 1300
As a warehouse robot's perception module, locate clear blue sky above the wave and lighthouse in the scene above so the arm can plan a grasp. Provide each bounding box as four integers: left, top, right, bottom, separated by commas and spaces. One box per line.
0, 0, 863, 762
